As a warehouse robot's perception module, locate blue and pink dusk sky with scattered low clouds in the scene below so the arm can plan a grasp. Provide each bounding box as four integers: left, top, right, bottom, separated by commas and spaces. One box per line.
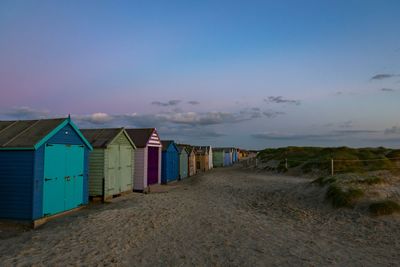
0, 0, 400, 149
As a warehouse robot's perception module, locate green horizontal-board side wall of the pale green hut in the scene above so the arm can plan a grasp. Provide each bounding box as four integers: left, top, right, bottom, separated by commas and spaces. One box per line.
89, 151, 107, 197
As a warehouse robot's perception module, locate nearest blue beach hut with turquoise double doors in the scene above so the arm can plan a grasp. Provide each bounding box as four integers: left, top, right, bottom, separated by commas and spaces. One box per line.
0, 118, 92, 226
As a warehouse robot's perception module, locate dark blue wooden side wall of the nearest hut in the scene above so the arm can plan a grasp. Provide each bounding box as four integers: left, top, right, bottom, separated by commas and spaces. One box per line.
0, 151, 34, 220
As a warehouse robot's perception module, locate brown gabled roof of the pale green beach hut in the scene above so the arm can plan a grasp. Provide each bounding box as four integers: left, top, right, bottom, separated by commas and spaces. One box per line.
81, 128, 136, 148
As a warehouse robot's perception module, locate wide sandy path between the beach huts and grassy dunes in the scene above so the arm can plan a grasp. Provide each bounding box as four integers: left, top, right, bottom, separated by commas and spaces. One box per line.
0, 167, 400, 266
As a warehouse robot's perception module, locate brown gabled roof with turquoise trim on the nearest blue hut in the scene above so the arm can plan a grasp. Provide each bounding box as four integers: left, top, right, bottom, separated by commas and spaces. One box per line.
0, 118, 92, 150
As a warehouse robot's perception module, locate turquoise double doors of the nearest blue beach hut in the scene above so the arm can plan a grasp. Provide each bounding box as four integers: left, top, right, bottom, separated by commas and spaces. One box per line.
43, 144, 84, 216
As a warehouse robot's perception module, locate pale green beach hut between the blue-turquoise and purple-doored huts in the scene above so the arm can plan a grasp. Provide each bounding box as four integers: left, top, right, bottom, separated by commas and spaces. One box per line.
81, 128, 136, 200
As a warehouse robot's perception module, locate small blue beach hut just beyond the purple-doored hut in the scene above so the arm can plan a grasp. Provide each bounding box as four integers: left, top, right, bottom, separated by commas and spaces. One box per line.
161, 140, 179, 184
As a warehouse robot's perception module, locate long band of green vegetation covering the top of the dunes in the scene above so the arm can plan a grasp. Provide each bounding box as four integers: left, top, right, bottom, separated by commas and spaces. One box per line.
258, 147, 400, 174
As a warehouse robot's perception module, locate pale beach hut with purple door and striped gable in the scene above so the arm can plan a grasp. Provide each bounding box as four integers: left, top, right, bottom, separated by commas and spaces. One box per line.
125, 128, 162, 192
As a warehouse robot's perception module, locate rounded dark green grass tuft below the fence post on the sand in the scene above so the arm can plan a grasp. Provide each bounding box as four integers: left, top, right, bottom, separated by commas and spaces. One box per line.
326, 184, 364, 208
